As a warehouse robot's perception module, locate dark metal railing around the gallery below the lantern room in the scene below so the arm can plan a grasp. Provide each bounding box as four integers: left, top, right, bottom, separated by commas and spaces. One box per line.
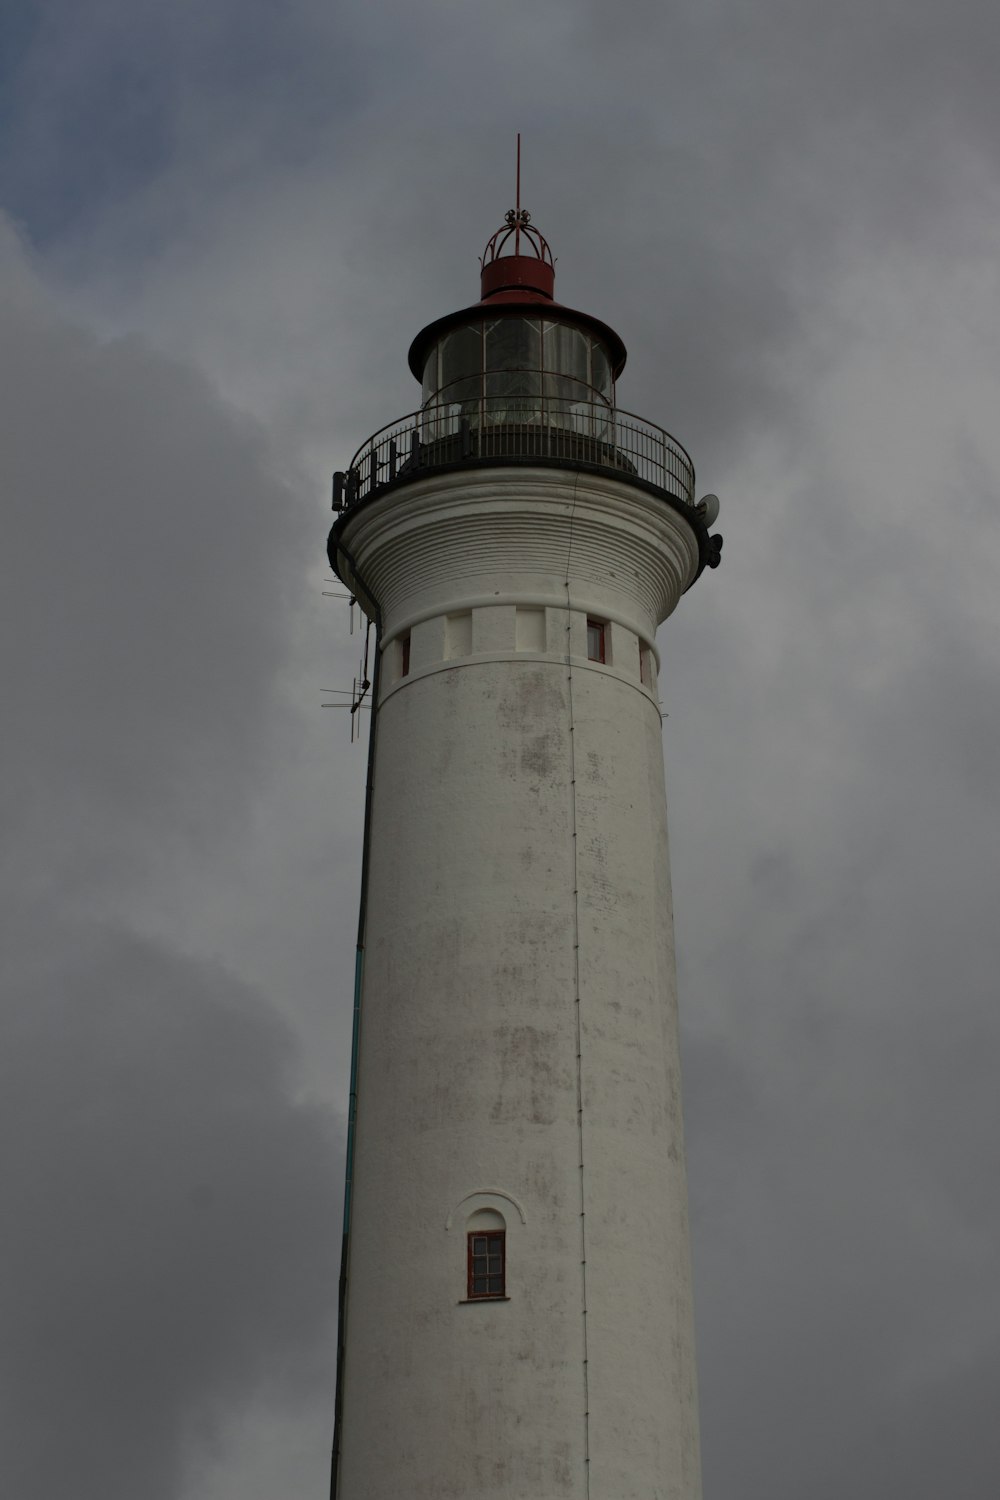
334, 395, 694, 510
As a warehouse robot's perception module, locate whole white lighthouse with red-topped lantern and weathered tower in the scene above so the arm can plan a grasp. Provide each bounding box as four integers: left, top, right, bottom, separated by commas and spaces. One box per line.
330, 196, 721, 1500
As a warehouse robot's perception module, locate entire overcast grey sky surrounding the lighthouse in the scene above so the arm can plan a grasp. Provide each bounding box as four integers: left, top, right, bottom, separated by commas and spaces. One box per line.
0, 0, 1000, 1500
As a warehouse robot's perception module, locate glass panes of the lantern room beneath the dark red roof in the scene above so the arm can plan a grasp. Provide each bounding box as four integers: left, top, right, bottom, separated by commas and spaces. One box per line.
423, 315, 615, 441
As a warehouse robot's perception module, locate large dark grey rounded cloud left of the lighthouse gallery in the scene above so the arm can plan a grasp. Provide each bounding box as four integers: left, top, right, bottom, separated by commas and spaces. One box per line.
0, 214, 301, 872
